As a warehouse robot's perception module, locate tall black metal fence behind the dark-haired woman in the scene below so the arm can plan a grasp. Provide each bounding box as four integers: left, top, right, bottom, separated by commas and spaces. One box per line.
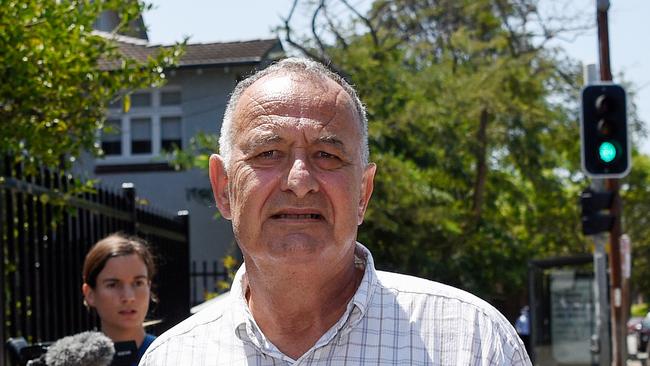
0, 158, 190, 366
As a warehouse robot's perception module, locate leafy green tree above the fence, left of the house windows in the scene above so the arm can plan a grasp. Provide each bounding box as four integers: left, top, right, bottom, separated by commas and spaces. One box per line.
0, 0, 181, 166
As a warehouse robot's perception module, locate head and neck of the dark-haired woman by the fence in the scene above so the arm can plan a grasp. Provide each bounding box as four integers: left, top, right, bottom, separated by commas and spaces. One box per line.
81, 234, 156, 365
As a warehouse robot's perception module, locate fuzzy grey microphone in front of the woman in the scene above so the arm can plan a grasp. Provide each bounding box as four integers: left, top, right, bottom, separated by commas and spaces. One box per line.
45, 332, 115, 366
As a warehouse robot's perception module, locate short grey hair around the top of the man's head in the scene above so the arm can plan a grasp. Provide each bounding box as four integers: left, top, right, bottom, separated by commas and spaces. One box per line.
219, 57, 370, 169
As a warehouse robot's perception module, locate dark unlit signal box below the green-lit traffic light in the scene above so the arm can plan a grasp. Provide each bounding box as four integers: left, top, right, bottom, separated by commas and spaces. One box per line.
580, 189, 614, 235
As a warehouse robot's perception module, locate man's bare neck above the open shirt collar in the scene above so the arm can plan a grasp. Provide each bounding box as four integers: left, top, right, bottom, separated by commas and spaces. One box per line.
243, 250, 364, 359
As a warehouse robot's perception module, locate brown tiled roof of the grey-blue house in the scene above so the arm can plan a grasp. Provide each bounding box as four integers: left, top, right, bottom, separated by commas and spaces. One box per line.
100, 39, 283, 69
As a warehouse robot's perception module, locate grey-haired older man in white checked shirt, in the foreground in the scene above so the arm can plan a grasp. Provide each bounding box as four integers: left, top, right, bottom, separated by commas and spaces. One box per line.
141, 58, 530, 366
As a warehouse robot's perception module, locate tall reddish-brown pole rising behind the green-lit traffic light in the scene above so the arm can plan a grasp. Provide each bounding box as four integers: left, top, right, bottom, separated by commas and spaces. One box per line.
596, 0, 627, 366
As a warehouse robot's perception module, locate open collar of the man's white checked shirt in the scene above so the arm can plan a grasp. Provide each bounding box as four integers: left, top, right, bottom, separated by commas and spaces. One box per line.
230, 242, 377, 357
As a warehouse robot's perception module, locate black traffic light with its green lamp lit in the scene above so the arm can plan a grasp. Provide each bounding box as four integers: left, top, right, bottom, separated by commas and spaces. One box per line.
580, 84, 631, 178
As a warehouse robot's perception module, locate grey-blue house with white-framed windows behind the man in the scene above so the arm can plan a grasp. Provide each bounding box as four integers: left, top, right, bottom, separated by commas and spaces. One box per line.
76, 13, 284, 300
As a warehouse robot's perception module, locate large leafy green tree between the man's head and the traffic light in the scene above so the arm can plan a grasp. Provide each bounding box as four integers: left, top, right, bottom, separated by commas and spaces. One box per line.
284, 0, 616, 310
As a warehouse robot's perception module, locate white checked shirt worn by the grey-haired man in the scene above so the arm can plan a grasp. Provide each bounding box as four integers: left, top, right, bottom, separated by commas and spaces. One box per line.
140, 243, 531, 366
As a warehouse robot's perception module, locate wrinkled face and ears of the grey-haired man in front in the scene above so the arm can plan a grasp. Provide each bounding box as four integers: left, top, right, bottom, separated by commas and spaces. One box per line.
210, 74, 375, 265
